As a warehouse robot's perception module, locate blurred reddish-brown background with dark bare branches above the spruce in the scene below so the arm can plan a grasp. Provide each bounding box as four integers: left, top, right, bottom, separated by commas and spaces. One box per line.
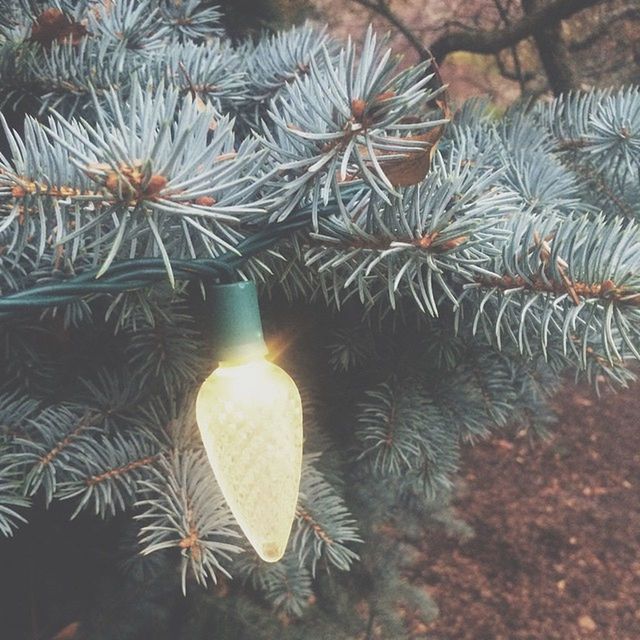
235, 0, 640, 106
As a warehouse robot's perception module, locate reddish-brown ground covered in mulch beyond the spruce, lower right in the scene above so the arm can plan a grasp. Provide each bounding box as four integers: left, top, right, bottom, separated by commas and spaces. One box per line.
415, 386, 640, 640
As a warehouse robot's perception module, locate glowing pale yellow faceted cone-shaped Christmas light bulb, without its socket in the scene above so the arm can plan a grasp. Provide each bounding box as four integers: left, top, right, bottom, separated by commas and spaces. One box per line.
196, 358, 302, 562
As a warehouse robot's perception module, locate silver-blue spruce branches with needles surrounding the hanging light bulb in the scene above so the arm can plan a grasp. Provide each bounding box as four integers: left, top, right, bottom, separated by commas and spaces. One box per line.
0, 0, 640, 638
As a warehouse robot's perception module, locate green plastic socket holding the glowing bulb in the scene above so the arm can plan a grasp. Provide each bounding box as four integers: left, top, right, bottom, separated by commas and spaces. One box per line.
207, 282, 267, 363
